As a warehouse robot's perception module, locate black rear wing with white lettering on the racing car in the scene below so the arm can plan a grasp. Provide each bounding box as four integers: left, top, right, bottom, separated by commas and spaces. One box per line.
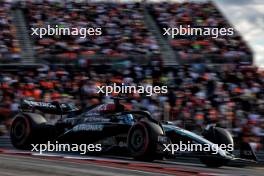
19, 100, 79, 115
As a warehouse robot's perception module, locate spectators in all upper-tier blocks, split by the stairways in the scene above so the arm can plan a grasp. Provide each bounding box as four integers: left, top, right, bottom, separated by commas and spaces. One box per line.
0, 0, 252, 63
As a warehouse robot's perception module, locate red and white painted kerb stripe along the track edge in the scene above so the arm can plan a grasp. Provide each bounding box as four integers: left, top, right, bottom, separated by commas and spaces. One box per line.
0, 149, 225, 176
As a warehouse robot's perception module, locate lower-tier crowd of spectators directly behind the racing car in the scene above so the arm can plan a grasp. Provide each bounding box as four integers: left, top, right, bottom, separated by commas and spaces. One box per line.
0, 62, 264, 148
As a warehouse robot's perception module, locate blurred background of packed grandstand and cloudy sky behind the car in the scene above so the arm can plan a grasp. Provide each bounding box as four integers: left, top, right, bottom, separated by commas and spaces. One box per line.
0, 0, 264, 150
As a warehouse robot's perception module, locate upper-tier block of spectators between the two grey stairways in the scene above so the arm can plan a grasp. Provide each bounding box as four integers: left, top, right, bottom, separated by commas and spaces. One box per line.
22, 1, 160, 62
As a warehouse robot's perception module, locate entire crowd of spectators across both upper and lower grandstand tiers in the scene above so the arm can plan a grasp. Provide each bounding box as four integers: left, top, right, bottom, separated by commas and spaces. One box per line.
0, 1, 264, 149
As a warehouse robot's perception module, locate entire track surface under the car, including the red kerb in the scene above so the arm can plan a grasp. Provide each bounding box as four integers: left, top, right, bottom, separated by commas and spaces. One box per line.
0, 137, 264, 176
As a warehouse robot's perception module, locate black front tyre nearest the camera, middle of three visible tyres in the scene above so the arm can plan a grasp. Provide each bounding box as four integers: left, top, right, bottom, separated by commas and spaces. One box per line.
127, 122, 157, 161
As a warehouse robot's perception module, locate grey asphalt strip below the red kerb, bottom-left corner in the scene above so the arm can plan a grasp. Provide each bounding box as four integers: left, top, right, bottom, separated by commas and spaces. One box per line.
0, 154, 168, 176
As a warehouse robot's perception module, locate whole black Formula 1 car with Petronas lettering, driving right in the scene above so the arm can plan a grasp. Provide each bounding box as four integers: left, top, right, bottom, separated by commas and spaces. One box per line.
10, 97, 257, 167
